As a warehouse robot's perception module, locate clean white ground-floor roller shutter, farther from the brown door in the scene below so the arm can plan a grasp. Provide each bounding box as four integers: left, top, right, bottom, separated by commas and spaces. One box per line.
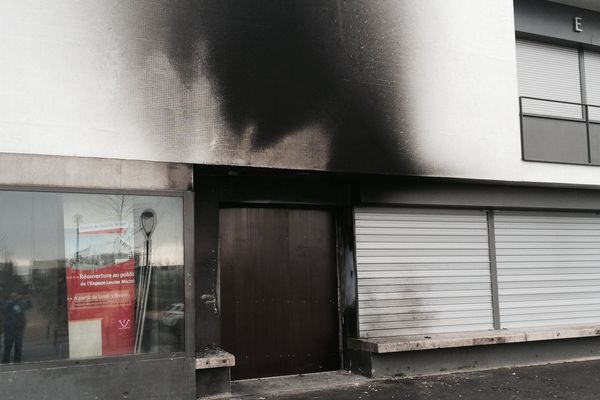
495, 212, 600, 328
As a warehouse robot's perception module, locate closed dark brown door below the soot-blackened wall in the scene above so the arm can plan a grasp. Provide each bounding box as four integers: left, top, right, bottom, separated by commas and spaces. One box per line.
219, 208, 340, 379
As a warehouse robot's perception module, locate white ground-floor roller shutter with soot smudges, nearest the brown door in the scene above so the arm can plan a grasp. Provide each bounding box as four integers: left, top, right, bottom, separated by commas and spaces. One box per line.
355, 208, 493, 337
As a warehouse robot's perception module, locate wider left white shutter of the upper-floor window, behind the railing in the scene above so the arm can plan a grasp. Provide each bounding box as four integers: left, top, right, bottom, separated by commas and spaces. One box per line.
517, 40, 583, 119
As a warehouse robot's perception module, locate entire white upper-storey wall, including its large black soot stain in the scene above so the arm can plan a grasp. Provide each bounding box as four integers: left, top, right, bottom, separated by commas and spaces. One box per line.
12, 0, 600, 185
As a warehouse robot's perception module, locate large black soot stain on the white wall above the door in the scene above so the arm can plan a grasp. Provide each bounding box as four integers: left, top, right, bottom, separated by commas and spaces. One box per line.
168, 0, 408, 172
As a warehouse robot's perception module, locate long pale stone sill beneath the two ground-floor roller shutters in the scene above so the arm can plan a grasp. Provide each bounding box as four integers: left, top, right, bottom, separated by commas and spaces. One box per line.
348, 325, 600, 353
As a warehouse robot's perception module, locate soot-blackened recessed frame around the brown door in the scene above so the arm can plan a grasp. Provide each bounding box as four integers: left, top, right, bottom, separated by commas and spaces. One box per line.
194, 166, 358, 376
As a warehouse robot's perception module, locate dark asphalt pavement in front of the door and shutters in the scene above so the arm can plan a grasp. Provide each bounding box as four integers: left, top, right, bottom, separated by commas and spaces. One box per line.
232, 360, 600, 400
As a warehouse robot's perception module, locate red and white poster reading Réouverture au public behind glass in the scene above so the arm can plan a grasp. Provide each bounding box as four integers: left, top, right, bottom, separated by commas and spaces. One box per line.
64, 200, 135, 358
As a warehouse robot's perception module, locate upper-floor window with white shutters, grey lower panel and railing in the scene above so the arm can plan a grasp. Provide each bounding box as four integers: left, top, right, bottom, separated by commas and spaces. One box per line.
517, 40, 600, 164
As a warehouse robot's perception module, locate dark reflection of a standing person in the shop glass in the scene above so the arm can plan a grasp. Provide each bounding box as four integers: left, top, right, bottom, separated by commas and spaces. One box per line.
1, 291, 31, 364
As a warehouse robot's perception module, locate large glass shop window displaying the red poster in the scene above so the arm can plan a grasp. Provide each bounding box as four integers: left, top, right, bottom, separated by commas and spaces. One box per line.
0, 191, 184, 363
